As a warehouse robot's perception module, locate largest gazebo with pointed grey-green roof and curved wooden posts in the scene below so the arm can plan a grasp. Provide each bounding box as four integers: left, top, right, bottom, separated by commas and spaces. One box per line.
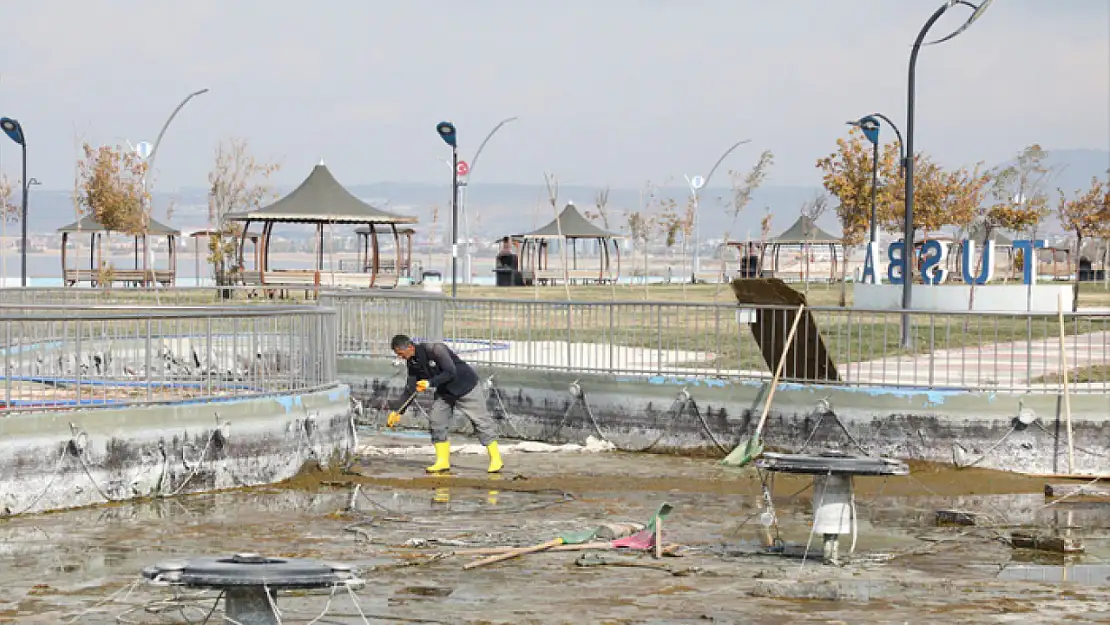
225, 161, 416, 288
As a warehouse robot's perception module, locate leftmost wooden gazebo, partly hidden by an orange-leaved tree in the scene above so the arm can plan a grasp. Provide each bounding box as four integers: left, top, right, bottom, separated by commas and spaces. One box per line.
58, 215, 181, 286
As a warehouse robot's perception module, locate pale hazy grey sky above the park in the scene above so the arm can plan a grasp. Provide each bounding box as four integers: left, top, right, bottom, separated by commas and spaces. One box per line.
0, 0, 1110, 191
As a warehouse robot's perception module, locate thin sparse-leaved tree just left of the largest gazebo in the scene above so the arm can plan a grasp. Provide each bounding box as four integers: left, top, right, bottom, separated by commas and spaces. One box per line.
208, 138, 280, 286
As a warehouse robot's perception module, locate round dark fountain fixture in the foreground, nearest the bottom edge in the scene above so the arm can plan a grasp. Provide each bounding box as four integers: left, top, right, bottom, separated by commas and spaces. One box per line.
142, 553, 364, 625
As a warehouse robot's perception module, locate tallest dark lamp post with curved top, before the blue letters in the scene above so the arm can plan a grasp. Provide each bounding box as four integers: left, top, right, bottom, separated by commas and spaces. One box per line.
901, 0, 992, 347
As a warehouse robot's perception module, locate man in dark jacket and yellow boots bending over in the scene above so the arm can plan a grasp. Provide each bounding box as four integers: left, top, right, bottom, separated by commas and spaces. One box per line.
386, 334, 502, 473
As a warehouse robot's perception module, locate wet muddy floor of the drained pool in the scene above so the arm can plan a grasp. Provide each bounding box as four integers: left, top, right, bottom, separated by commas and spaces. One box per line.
0, 434, 1110, 624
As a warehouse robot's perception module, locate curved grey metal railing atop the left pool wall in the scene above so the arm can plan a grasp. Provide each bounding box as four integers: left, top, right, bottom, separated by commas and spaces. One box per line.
0, 304, 337, 412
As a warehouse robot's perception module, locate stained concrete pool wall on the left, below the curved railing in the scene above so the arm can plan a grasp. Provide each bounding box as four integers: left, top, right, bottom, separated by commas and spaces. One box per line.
0, 384, 356, 516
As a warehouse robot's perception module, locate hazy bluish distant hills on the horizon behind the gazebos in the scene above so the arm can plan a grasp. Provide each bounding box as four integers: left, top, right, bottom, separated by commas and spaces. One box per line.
21, 150, 1110, 240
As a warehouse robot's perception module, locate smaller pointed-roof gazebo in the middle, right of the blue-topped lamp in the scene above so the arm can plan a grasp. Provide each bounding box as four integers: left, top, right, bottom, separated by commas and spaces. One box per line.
503, 202, 623, 284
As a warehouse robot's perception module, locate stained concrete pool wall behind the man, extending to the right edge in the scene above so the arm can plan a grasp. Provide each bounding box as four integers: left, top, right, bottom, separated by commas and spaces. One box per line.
339, 357, 1110, 474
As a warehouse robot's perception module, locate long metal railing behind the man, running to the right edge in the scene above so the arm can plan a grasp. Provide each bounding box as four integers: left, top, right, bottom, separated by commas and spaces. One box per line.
321, 292, 1110, 393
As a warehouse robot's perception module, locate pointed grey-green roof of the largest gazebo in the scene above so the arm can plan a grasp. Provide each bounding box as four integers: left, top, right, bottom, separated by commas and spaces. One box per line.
226, 162, 416, 223
